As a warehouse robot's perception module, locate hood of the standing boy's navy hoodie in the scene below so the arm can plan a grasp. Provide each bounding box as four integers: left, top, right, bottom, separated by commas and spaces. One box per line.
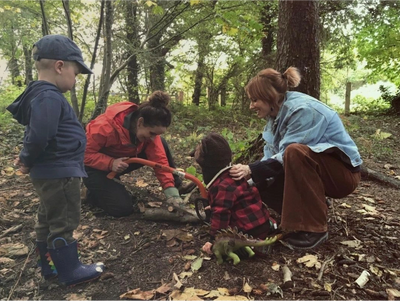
7, 80, 60, 125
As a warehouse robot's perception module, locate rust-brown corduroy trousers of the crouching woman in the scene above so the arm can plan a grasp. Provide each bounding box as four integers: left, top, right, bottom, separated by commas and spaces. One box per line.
261, 143, 361, 232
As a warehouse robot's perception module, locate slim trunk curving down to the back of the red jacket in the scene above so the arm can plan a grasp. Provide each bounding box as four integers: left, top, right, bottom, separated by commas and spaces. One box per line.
91, 0, 113, 119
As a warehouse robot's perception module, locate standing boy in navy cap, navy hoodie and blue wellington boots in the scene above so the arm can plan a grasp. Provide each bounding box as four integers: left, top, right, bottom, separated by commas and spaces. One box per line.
7, 35, 104, 286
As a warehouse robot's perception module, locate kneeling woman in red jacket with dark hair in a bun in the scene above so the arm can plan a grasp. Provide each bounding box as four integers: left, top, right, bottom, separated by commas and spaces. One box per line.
83, 91, 181, 217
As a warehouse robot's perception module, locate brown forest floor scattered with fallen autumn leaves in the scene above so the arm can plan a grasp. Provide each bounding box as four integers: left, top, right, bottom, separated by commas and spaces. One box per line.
0, 110, 400, 301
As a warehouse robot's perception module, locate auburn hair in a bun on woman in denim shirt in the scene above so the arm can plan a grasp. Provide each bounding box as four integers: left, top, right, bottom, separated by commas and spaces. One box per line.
245, 67, 301, 108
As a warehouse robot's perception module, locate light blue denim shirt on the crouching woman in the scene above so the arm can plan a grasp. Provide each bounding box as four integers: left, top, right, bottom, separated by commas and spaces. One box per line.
262, 92, 362, 167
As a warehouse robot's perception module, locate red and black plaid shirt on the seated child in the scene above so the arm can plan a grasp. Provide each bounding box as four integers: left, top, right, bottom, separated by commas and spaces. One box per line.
208, 170, 269, 236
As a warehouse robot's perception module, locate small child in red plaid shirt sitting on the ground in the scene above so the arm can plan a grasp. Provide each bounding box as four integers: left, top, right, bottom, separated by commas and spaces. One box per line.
194, 133, 277, 254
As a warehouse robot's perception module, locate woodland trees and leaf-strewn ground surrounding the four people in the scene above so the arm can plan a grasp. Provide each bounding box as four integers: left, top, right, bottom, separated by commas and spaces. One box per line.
0, 0, 400, 301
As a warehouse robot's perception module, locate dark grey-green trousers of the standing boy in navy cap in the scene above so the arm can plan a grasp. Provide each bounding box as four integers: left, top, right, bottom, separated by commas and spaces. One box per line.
31, 178, 81, 248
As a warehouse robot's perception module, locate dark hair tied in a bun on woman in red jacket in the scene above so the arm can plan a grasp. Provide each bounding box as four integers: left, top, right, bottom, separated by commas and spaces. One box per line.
137, 91, 171, 127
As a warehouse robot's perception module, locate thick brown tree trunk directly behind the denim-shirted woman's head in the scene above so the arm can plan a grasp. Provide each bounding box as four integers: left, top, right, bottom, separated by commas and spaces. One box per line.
276, 0, 320, 99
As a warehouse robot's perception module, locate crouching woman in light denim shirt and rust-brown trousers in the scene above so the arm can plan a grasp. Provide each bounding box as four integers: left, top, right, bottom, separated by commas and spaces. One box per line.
230, 67, 362, 249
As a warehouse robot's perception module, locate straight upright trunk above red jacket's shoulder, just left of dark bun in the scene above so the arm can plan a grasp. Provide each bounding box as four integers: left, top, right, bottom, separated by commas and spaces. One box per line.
125, 0, 140, 103
